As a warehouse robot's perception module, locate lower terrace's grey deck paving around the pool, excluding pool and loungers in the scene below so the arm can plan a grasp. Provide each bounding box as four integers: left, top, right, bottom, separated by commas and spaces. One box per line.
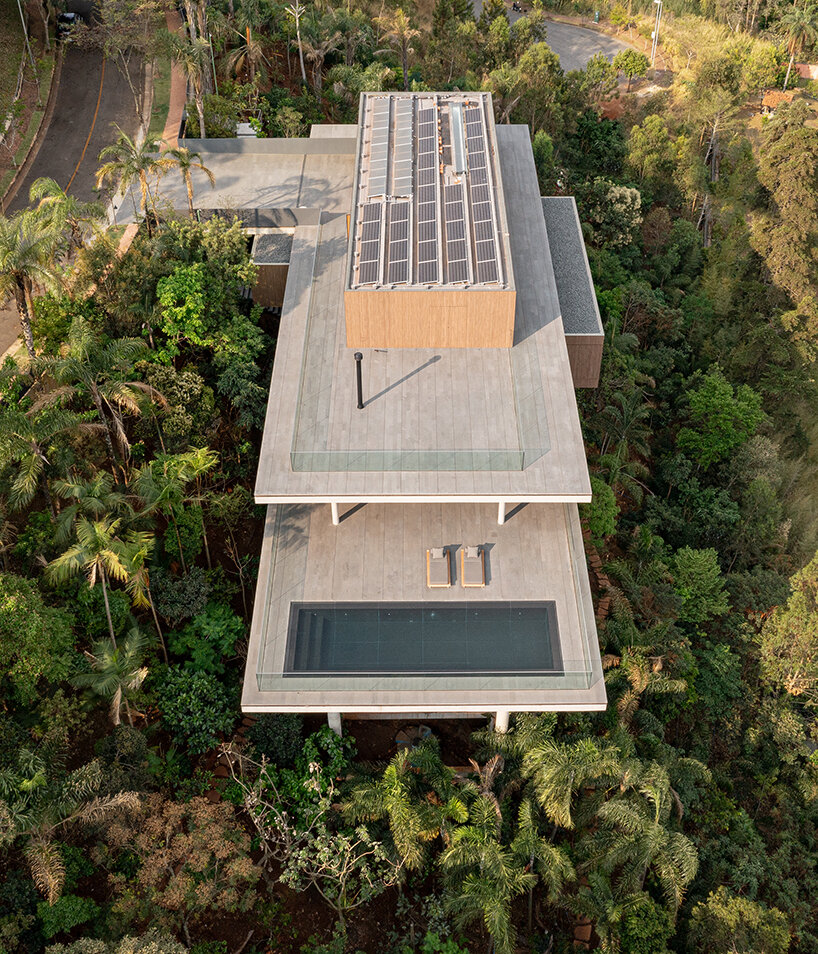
242, 503, 606, 712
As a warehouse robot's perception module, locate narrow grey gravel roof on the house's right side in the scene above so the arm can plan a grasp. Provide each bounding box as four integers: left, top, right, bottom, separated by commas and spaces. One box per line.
542, 196, 603, 335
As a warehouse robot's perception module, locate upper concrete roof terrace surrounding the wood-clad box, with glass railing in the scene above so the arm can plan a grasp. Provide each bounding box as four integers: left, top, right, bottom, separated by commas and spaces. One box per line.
255, 126, 590, 503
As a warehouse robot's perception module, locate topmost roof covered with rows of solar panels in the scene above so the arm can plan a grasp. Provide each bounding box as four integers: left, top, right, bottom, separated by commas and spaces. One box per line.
354, 93, 503, 285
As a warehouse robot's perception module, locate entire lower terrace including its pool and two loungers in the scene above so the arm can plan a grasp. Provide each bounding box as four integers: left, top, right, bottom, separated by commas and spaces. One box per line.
242, 494, 606, 728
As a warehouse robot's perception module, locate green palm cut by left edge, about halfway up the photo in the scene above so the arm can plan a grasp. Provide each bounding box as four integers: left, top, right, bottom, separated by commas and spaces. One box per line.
0, 404, 93, 519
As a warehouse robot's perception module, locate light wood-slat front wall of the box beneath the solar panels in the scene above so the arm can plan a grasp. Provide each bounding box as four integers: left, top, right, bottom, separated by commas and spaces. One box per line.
344, 288, 517, 348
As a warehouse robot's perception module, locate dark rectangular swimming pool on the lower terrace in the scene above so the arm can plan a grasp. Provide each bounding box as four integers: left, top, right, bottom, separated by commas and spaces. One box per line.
284, 600, 562, 676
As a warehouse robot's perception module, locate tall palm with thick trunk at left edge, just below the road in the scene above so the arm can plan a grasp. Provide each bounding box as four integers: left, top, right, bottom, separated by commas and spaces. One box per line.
0, 209, 60, 359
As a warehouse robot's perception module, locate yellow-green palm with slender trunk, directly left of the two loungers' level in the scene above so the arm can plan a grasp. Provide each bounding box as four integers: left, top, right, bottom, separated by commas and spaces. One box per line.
45, 516, 129, 648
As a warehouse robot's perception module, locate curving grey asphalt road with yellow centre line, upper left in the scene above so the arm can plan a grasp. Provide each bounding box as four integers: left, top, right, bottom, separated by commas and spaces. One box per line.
9, 45, 144, 212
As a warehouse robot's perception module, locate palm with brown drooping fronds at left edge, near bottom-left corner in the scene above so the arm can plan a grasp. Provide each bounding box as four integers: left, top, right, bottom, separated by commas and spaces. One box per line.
0, 745, 139, 904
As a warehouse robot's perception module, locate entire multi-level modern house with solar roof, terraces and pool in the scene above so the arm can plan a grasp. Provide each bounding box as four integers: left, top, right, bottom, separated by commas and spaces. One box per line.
174, 93, 606, 731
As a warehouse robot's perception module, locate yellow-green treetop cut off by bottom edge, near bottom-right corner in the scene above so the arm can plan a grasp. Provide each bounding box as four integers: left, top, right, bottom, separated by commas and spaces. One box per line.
690, 885, 790, 954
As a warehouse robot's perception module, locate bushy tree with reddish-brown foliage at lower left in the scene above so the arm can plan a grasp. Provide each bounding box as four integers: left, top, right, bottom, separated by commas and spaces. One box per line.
105, 794, 260, 947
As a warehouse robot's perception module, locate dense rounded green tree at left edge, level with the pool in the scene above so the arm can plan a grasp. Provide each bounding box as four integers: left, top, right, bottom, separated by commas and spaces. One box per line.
0, 573, 74, 704
